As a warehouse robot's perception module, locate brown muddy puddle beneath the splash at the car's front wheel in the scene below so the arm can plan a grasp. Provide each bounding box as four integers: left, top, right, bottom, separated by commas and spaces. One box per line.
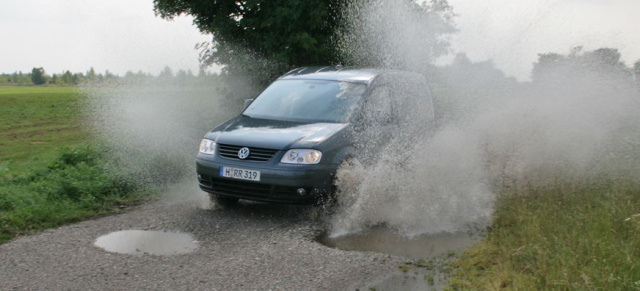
316, 227, 480, 259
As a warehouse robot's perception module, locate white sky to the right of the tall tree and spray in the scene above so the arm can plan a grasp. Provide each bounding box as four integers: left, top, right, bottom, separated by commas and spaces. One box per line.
449, 0, 640, 80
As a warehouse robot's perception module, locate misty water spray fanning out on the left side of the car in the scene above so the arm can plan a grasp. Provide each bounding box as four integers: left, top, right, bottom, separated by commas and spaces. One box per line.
83, 80, 241, 184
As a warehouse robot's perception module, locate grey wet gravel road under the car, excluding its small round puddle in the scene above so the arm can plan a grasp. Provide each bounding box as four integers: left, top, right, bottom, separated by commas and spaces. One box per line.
0, 185, 403, 290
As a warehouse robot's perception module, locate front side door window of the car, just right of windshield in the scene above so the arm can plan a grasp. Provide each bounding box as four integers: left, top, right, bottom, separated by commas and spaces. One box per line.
363, 85, 395, 125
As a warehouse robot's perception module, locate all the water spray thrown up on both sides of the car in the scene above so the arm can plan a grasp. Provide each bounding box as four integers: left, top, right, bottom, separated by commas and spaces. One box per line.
81, 0, 640, 240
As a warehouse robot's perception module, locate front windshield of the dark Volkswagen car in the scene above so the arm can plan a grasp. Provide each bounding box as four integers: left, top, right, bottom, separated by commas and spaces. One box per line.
243, 80, 367, 122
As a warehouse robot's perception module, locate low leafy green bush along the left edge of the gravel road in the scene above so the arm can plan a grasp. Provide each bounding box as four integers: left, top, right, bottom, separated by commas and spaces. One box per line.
0, 146, 143, 243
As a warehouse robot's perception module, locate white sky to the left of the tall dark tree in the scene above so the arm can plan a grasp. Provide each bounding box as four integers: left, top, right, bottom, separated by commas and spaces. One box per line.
0, 0, 211, 75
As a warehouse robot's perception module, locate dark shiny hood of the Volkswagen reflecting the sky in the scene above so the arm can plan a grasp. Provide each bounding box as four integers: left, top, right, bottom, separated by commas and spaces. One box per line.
206, 116, 348, 149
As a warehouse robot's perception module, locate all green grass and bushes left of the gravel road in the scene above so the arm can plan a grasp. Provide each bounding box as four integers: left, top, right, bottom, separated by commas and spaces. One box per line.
0, 86, 143, 243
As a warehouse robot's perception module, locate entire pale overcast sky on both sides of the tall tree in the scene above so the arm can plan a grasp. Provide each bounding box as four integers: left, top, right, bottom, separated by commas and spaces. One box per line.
0, 0, 640, 80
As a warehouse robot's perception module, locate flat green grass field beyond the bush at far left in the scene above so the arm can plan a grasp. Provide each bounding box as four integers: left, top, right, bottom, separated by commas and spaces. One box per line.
0, 86, 91, 170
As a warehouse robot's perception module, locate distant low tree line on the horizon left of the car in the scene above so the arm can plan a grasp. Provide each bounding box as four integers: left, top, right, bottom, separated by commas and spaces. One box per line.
0, 66, 220, 86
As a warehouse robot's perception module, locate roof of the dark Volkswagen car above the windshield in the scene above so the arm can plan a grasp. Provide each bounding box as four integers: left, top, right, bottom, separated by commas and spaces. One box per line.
278, 66, 382, 84
